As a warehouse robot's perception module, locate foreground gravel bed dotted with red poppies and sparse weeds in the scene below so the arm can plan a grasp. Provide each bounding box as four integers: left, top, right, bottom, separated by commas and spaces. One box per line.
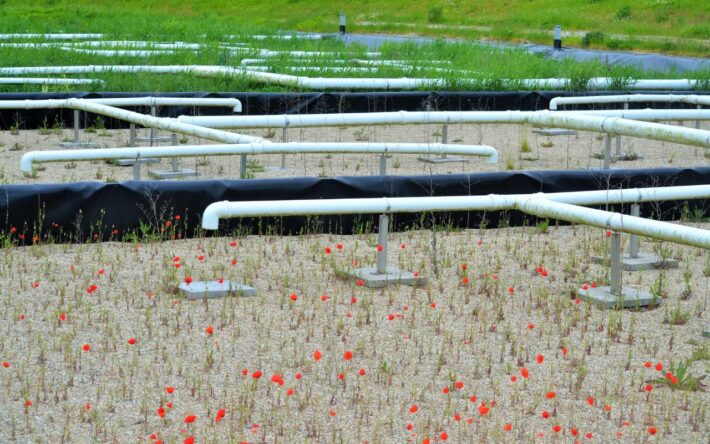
0, 227, 710, 443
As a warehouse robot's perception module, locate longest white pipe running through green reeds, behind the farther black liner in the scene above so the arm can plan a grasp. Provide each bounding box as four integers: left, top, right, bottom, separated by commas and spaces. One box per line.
0, 65, 697, 90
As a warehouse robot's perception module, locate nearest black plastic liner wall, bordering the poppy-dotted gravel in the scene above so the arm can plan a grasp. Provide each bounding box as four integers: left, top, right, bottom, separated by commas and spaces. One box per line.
0, 167, 710, 243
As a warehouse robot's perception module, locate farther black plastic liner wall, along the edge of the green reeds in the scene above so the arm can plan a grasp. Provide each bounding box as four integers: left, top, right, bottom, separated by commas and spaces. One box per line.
0, 91, 710, 130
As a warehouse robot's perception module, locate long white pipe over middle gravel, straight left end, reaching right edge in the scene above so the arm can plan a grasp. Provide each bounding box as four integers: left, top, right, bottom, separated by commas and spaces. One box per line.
178, 110, 710, 148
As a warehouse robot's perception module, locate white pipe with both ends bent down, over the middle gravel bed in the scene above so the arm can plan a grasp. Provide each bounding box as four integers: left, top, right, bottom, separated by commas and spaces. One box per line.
20, 142, 498, 173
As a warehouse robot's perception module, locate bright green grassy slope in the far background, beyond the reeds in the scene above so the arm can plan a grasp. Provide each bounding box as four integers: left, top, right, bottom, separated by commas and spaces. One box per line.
0, 0, 710, 56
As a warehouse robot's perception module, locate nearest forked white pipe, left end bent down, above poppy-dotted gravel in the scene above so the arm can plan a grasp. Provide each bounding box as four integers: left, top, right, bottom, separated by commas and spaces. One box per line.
202, 185, 710, 249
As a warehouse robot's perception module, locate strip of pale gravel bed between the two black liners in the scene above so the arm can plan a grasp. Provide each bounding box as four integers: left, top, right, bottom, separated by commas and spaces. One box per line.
0, 122, 710, 183
